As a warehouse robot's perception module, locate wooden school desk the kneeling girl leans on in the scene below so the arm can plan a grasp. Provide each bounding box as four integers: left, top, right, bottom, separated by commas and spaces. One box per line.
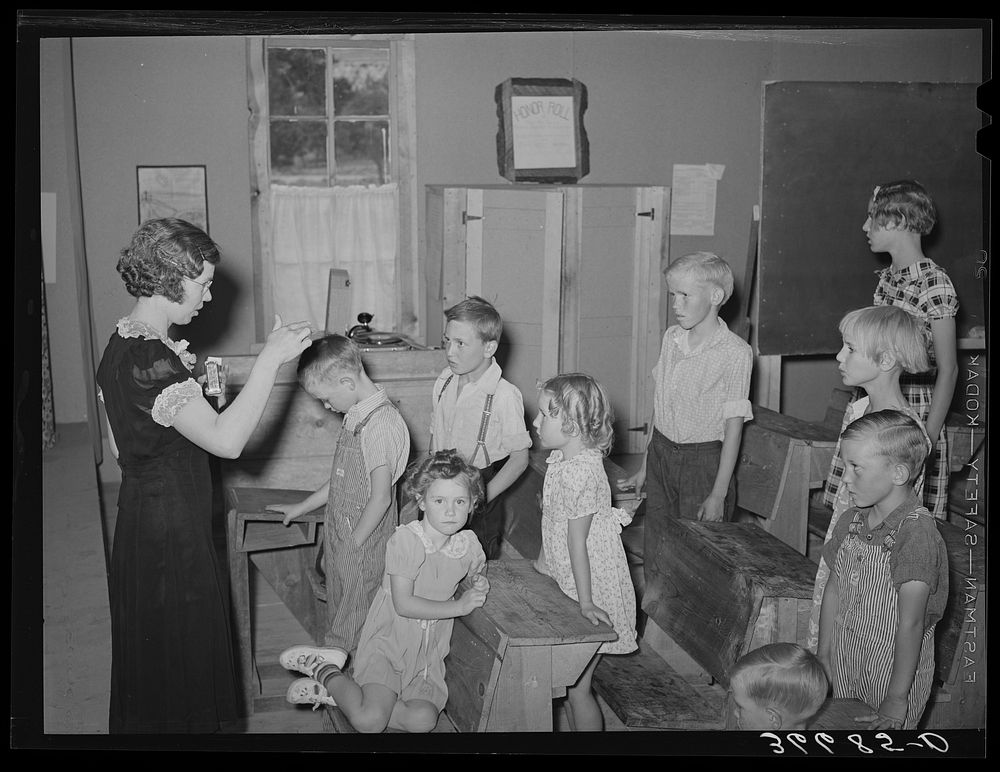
445, 558, 616, 732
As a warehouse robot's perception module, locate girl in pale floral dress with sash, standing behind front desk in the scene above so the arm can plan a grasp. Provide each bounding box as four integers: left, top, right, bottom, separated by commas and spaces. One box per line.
534, 373, 638, 731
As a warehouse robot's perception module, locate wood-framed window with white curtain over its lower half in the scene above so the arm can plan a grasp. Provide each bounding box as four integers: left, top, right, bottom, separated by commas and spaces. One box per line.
254, 35, 421, 343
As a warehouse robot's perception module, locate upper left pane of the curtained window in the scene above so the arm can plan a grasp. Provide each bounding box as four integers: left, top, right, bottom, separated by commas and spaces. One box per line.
267, 48, 326, 116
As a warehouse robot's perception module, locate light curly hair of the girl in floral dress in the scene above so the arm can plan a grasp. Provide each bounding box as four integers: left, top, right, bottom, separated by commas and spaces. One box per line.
538, 373, 615, 453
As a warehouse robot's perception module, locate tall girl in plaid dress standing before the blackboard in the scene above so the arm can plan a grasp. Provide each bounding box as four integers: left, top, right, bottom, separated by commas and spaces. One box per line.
825, 180, 958, 519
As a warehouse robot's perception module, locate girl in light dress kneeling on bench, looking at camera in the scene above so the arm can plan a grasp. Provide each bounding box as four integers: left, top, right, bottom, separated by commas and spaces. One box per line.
281, 450, 489, 732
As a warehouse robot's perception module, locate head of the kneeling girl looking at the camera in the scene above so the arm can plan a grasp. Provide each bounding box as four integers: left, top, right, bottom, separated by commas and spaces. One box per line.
406, 449, 485, 536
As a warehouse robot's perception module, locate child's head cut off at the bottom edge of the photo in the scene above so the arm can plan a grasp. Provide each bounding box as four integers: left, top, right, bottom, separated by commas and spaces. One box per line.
729, 643, 829, 731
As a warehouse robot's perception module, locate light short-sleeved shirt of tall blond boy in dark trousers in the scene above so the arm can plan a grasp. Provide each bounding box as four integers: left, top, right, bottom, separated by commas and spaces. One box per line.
653, 319, 753, 444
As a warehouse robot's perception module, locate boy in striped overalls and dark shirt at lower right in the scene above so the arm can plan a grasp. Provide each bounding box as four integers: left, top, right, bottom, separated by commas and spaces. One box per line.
817, 410, 948, 729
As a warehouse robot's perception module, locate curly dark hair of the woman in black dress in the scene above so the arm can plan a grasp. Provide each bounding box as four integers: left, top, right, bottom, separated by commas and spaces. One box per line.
116, 217, 219, 303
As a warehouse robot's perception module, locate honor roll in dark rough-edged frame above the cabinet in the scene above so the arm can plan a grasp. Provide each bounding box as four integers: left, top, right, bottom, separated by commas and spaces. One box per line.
494, 78, 590, 183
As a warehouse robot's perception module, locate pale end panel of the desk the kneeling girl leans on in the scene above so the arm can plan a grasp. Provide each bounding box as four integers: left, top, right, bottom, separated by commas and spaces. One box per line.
486, 646, 552, 732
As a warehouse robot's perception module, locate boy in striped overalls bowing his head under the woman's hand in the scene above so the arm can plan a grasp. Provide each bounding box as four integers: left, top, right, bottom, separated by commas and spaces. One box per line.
267, 335, 410, 666
